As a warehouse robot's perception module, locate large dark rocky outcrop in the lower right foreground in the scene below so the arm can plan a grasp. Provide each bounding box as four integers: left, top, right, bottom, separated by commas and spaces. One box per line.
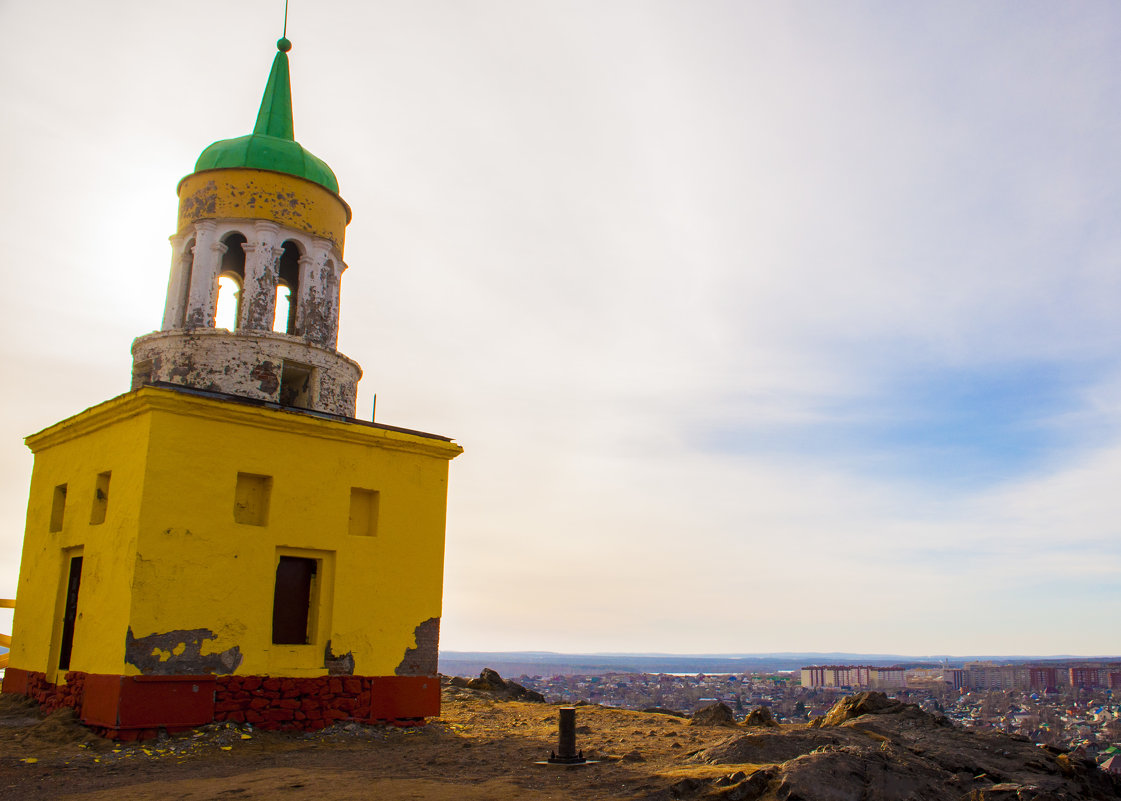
679, 692, 1121, 801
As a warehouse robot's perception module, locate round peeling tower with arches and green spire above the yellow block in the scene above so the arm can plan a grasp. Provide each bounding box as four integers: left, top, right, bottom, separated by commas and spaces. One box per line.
132, 38, 362, 417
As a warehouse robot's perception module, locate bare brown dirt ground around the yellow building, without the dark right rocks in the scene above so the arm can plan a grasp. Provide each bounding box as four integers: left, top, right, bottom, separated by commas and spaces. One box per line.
0, 687, 757, 801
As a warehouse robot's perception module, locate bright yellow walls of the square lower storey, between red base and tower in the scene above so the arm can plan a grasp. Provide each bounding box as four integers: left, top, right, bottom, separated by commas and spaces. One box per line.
12, 388, 461, 676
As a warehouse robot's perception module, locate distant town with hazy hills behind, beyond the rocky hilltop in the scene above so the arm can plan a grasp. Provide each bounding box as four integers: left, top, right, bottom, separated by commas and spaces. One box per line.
441, 652, 1121, 763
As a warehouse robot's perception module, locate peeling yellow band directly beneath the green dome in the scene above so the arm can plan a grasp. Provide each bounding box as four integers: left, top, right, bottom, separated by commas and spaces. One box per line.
178, 168, 351, 251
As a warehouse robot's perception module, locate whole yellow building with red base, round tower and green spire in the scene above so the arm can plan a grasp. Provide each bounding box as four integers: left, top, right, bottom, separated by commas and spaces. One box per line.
3, 39, 462, 737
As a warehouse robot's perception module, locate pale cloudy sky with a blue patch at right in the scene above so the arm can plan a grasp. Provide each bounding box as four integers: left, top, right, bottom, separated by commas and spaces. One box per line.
0, 0, 1121, 655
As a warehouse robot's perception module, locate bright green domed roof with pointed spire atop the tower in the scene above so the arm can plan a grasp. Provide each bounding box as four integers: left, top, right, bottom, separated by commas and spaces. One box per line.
195, 39, 339, 195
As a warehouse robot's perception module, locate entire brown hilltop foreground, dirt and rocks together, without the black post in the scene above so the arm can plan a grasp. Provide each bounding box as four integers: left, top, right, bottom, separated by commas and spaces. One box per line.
0, 676, 1121, 801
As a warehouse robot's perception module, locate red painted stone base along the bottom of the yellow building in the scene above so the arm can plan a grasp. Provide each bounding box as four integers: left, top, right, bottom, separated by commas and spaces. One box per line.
2, 668, 439, 739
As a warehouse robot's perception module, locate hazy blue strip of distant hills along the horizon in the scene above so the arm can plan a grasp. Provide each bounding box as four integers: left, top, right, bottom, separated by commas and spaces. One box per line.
439, 651, 1119, 676
